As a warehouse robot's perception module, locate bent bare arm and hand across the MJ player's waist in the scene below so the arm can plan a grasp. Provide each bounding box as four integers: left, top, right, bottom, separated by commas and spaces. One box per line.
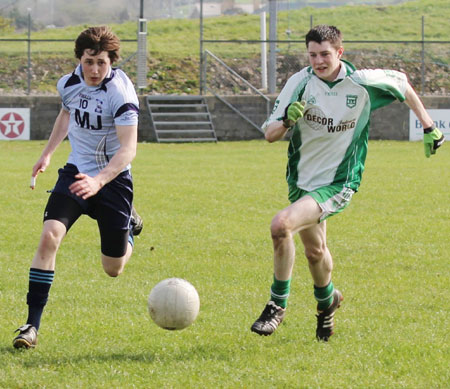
69, 125, 137, 199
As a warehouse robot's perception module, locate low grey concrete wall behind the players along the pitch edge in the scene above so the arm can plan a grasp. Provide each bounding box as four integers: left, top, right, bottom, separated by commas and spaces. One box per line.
0, 96, 450, 142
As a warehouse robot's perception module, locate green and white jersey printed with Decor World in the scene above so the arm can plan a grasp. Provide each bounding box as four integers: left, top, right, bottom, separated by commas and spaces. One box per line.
262, 61, 407, 191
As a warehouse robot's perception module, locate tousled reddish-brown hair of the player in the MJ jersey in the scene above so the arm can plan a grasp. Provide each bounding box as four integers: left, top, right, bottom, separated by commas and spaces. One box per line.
74, 26, 120, 63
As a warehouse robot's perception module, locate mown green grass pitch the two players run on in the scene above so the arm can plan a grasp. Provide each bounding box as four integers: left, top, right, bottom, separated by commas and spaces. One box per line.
0, 141, 450, 388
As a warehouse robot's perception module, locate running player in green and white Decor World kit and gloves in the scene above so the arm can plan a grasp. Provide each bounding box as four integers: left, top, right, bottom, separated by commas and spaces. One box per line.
251, 25, 444, 341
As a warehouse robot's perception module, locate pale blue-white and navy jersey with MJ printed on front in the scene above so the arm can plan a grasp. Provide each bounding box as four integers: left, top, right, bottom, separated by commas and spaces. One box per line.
57, 65, 139, 176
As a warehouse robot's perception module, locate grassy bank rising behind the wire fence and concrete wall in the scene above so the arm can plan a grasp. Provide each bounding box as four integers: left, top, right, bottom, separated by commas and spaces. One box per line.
0, 0, 450, 93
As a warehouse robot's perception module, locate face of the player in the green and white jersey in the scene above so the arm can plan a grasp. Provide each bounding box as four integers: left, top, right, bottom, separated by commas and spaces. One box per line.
308, 41, 344, 81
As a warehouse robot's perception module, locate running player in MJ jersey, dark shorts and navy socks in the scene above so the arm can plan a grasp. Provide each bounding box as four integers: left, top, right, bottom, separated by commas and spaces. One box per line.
13, 26, 142, 348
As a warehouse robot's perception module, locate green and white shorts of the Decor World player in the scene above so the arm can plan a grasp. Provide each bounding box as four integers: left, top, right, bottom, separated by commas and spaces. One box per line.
289, 185, 355, 221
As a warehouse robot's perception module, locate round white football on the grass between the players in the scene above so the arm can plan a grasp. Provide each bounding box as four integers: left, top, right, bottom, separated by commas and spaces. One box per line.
148, 278, 200, 330
